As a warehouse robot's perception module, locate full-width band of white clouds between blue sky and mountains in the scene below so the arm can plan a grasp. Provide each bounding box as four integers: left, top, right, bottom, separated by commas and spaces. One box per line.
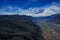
0, 2, 60, 17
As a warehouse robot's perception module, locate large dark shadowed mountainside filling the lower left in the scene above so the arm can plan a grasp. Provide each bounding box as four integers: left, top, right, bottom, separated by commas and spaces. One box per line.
0, 15, 42, 40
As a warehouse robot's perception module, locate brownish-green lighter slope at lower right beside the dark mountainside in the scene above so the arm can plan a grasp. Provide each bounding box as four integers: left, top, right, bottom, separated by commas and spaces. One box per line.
37, 21, 60, 40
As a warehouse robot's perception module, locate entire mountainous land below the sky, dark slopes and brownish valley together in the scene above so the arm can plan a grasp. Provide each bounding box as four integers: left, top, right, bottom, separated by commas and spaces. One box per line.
0, 14, 60, 40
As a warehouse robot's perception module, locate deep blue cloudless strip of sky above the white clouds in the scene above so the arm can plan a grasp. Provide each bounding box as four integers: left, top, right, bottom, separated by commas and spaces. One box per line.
0, 0, 60, 8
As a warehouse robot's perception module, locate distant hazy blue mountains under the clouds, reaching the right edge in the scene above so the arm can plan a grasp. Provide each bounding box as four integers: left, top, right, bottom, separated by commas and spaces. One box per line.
21, 14, 60, 24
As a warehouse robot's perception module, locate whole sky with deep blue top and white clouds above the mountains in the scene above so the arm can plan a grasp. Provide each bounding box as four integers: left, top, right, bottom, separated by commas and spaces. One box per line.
0, 0, 60, 17
